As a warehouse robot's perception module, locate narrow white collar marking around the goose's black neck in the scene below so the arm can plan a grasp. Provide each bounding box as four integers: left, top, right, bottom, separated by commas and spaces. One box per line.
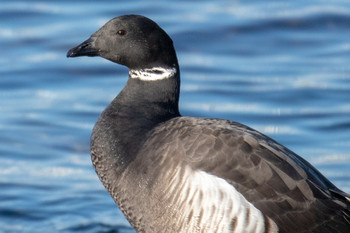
129, 67, 176, 81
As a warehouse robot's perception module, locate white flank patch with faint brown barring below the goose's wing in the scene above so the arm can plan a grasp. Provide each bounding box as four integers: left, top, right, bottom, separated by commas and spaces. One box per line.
163, 167, 277, 233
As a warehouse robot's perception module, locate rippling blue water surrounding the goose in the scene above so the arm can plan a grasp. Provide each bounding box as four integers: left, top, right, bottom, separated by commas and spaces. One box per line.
0, 0, 350, 232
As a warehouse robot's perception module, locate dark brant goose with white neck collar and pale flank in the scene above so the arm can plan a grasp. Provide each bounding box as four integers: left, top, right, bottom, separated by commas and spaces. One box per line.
67, 15, 350, 233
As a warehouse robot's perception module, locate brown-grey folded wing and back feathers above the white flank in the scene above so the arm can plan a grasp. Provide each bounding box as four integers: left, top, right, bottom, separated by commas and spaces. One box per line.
143, 117, 350, 232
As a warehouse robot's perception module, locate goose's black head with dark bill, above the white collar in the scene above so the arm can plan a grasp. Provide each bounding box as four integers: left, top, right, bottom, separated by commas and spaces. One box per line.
67, 15, 177, 69
